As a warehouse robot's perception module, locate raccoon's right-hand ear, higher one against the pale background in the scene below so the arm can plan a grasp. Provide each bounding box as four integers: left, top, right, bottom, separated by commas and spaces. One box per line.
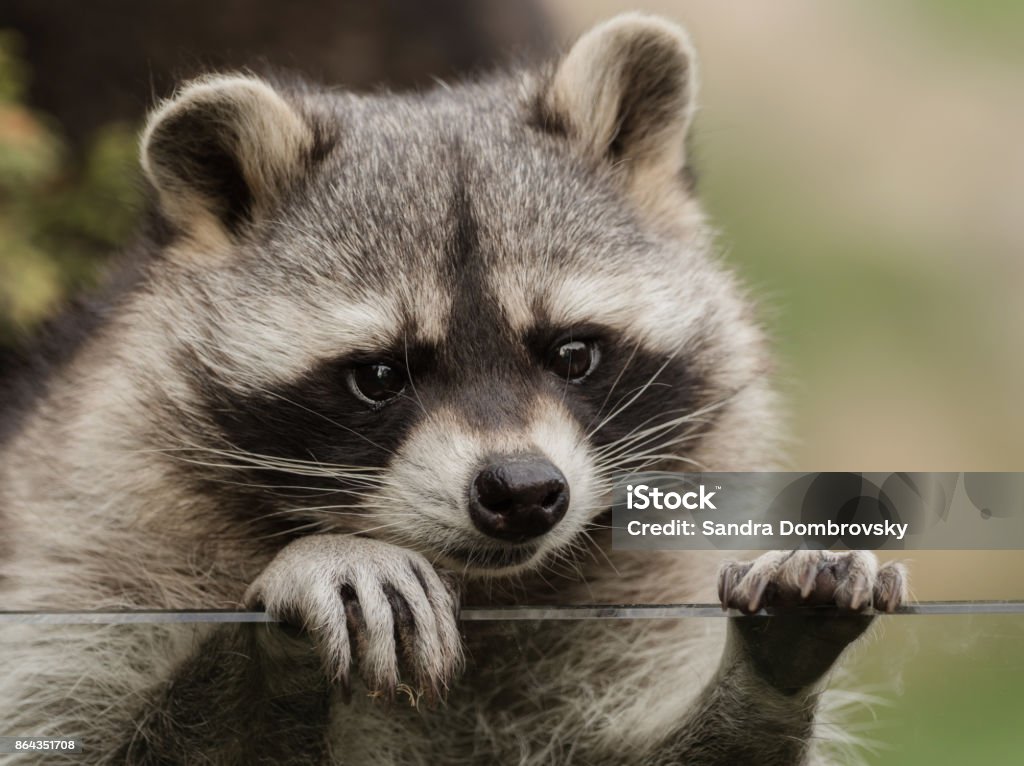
538, 13, 697, 209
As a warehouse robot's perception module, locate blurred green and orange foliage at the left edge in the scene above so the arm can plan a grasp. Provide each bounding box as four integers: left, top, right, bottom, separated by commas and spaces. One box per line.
0, 31, 140, 343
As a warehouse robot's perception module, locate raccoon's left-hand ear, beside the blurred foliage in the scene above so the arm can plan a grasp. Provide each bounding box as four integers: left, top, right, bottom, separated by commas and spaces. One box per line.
141, 75, 315, 235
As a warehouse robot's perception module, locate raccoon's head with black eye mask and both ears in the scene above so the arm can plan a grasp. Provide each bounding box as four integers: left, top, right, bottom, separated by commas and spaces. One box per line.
134, 15, 773, 575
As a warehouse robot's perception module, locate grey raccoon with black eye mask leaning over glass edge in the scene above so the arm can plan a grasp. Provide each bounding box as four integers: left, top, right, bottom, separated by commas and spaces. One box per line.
0, 14, 906, 766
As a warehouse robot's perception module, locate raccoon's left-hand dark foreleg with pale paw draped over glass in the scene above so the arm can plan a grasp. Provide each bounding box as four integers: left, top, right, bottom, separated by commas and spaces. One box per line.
117, 535, 462, 764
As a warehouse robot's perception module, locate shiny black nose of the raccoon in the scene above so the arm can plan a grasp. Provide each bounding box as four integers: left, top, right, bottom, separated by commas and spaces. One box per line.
469, 456, 569, 543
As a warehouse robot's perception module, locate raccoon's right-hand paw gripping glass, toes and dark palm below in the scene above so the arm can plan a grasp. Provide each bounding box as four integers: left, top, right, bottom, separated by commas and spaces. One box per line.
718, 551, 907, 694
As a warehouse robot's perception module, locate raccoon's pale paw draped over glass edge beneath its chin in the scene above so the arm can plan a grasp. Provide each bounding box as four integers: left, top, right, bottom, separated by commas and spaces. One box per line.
246, 535, 463, 703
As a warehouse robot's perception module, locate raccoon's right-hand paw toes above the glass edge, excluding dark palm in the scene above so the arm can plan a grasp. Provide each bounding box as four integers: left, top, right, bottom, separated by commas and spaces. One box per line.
718, 551, 907, 614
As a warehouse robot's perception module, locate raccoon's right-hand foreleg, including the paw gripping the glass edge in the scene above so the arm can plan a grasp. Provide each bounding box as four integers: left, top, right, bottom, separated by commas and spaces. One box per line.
634, 551, 906, 766
